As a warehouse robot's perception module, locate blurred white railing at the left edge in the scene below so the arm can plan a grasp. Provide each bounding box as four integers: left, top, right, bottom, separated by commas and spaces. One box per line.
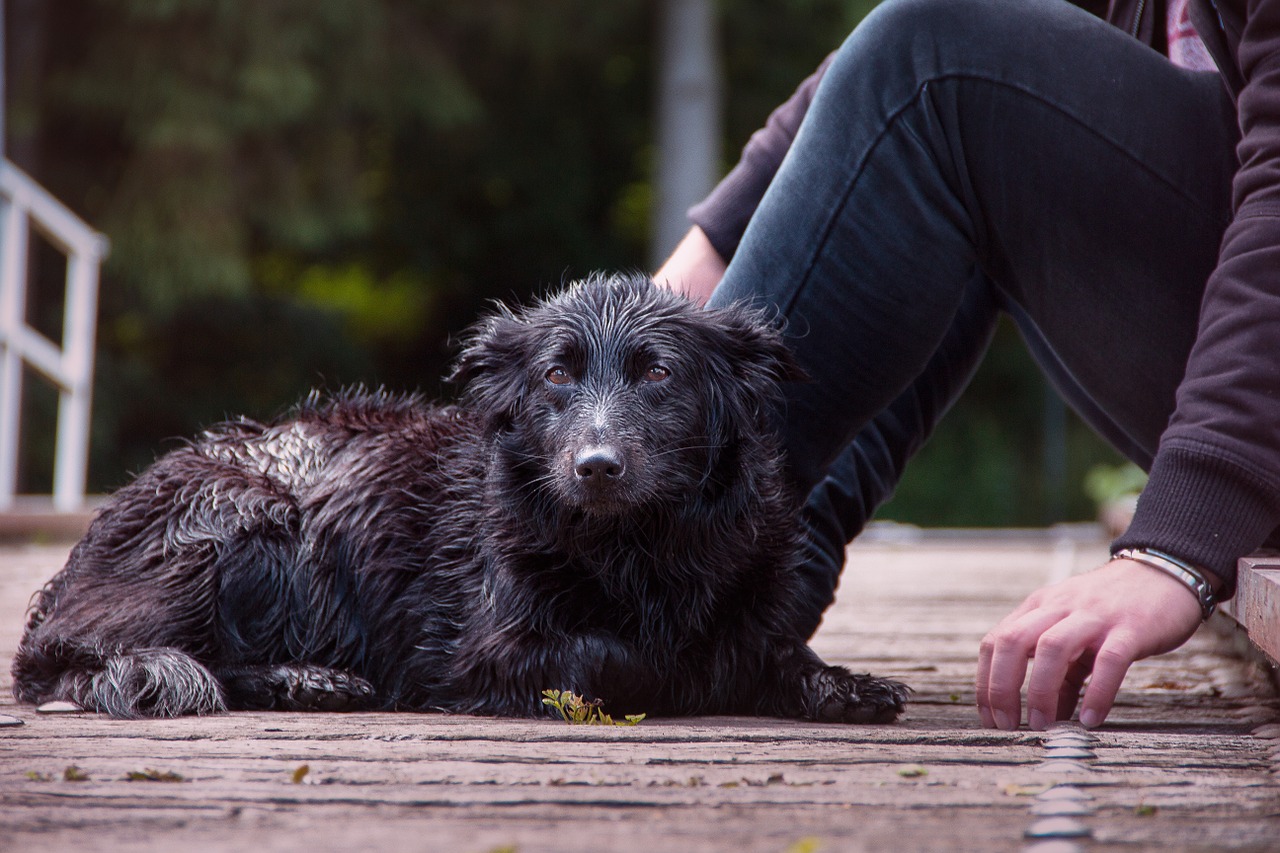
0, 160, 108, 504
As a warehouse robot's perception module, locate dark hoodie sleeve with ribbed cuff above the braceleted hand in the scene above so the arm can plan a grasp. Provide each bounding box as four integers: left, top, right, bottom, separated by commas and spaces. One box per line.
1116, 0, 1280, 594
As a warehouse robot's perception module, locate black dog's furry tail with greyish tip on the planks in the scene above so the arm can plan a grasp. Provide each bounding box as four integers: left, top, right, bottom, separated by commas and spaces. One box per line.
13, 640, 227, 719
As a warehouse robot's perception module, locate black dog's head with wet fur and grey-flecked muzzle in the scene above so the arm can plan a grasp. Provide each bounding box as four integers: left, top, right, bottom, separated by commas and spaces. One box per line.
451, 275, 800, 515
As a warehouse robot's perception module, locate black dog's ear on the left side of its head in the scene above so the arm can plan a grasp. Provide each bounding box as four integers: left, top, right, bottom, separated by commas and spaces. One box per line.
445, 305, 531, 425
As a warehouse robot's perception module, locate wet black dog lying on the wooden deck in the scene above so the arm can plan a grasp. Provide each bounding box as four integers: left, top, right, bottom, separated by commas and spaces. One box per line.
13, 277, 908, 722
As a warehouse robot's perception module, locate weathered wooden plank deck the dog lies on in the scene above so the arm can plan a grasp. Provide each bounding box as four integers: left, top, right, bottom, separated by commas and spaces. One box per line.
0, 527, 1280, 853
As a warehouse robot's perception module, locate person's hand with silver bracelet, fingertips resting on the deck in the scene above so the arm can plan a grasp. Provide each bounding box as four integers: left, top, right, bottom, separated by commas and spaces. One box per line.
977, 560, 1201, 731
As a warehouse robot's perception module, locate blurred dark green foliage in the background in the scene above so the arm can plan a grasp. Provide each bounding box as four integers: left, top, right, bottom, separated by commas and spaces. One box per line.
6, 0, 1131, 524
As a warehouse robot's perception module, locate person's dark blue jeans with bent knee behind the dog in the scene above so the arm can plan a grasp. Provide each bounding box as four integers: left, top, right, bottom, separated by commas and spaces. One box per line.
712, 0, 1239, 635
